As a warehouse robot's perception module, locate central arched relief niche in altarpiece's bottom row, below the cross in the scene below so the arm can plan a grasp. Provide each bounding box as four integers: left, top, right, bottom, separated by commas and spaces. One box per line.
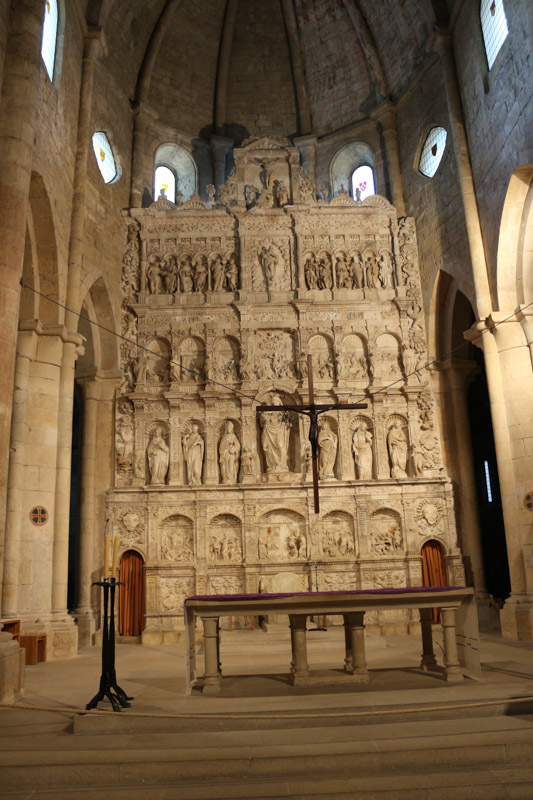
258, 508, 307, 561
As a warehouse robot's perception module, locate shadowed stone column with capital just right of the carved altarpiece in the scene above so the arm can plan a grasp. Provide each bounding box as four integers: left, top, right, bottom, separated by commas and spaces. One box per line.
442, 359, 487, 595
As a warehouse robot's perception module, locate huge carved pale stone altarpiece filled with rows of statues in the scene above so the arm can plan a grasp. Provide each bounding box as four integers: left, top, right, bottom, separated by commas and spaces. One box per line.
107, 137, 464, 642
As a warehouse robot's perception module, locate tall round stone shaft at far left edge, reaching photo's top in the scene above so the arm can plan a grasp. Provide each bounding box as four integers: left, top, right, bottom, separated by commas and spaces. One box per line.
0, 0, 44, 608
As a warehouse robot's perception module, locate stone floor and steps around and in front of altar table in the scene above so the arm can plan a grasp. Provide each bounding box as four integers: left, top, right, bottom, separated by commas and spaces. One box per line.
0, 624, 533, 800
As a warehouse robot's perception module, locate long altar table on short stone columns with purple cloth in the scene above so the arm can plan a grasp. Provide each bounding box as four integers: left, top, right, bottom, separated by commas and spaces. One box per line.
184, 586, 480, 694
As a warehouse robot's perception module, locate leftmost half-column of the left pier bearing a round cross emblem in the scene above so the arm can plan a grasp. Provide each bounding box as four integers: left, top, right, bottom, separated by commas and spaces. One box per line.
2, 321, 42, 617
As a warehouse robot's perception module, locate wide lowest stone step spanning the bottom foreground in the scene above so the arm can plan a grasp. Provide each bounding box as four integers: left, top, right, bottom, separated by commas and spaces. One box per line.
0, 717, 533, 800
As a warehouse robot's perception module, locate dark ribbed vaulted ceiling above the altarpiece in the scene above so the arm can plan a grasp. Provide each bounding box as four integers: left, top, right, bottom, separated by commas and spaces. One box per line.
86, 0, 438, 140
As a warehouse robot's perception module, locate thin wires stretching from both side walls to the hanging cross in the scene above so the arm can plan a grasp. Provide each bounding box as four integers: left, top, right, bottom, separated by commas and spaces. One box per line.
20, 278, 533, 406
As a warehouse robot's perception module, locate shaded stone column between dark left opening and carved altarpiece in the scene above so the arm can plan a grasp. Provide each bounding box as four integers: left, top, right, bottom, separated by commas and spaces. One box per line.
76, 378, 100, 646
